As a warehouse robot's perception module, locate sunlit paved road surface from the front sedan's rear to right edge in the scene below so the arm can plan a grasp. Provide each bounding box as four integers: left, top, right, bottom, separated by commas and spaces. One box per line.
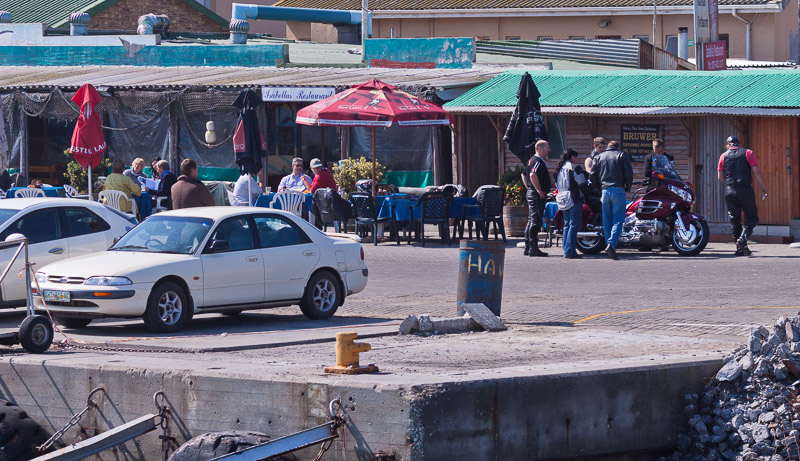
337, 240, 800, 337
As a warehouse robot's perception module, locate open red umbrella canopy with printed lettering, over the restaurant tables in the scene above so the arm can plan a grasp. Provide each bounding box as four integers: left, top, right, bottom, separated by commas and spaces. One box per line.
297, 79, 453, 127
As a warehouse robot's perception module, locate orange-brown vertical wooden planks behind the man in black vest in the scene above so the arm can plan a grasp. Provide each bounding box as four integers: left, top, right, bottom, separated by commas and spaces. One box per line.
742, 117, 799, 226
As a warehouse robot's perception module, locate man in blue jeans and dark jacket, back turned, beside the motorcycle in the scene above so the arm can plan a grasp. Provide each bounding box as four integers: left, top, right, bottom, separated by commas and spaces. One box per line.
592, 141, 633, 259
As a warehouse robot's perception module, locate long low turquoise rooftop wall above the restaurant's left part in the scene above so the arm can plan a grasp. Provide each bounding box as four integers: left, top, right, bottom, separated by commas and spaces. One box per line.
0, 44, 284, 67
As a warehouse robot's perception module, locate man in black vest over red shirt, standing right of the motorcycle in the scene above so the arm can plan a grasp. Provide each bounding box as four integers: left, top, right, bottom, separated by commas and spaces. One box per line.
717, 136, 767, 256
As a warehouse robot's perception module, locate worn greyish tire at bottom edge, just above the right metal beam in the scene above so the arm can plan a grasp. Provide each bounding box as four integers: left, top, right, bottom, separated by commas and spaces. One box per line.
168, 431, 297, 461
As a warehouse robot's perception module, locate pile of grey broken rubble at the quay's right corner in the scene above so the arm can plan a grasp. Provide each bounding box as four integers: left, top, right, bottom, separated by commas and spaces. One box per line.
661, 316, 800, 461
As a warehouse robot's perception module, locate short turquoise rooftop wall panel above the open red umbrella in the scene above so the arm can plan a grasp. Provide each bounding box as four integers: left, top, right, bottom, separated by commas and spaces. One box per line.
364, 38, 475, 69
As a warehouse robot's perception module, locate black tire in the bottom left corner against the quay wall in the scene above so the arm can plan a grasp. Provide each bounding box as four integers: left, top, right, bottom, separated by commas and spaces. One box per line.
0, 400, 48, 461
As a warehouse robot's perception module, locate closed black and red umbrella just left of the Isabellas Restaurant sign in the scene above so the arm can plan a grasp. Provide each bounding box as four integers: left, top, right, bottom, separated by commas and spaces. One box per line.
231, 89, 267, 205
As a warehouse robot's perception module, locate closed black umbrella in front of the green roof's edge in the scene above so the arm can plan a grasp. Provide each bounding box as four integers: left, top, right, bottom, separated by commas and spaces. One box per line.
503, 72, 547, 163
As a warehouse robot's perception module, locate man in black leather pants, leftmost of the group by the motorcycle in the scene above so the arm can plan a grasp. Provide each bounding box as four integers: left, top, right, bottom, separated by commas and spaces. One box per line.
522, 140, 550, 256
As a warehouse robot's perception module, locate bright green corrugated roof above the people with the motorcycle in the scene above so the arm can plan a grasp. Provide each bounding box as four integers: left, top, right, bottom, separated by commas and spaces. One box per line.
445, 70, 800, 108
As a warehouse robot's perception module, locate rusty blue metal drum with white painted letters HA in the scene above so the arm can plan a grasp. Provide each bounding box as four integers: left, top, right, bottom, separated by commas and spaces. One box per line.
456, 240, 506, 317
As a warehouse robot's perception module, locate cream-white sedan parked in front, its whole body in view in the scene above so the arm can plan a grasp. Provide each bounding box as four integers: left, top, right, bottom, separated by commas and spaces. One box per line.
34, 207, 367, 332
